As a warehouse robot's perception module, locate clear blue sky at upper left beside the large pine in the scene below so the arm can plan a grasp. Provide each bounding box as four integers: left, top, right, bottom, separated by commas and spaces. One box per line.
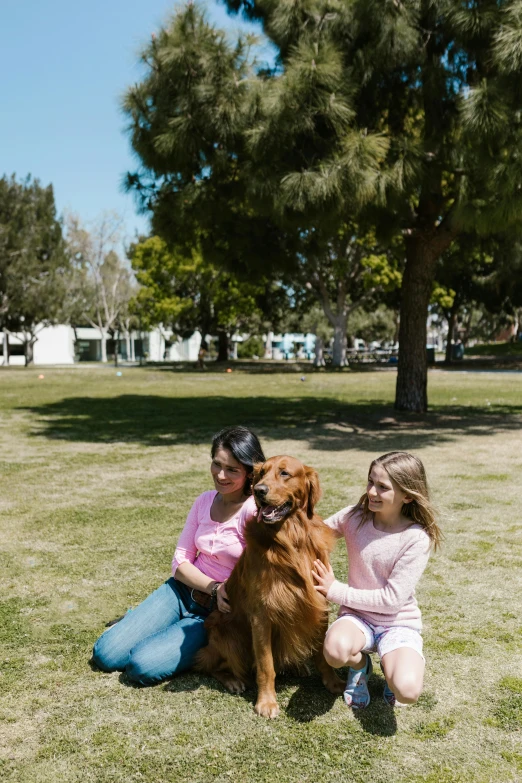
0, 0, 266, 236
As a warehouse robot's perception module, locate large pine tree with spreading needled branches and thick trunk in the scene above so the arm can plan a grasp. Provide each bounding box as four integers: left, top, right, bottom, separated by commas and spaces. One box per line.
125, 0, 522, 411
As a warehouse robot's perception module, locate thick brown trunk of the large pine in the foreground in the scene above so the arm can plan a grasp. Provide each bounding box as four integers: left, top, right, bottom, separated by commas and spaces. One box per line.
395, 235, 440, 413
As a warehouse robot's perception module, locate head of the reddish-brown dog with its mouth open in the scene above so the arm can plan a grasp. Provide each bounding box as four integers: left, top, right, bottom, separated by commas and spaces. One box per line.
252, 456, 321, 525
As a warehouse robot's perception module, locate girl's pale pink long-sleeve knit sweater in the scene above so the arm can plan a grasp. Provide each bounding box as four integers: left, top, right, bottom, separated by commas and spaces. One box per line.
325, 506, 430, 631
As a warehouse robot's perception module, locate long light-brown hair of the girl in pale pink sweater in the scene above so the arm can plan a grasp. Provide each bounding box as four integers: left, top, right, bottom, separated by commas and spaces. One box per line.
353, 451, 444, 549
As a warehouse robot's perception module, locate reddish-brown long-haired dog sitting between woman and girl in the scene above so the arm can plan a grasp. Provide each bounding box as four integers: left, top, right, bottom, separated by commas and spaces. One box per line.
196, 456, 343, 718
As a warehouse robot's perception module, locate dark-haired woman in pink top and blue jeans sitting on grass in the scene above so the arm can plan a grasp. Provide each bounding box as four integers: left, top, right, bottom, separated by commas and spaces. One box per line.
93, 427, 265, 685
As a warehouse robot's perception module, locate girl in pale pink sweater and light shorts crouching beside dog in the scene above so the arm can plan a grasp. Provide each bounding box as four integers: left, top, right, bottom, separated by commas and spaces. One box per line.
312, 451, 442, 708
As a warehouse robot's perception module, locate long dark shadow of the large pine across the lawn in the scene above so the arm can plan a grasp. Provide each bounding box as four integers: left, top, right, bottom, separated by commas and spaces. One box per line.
18, 394, 522, 451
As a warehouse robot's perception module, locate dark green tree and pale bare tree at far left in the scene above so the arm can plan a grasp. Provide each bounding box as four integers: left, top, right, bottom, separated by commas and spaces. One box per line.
0, 175, 136, 364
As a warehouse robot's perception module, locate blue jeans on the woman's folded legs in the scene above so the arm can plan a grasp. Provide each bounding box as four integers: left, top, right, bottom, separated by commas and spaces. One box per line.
92, 577, 209, 685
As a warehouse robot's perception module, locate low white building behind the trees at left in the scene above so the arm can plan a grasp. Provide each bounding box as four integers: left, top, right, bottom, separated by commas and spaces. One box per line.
0, 324, 201, 365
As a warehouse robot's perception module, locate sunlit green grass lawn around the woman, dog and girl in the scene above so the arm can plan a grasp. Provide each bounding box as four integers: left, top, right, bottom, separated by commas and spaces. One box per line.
0, 367, 522, 783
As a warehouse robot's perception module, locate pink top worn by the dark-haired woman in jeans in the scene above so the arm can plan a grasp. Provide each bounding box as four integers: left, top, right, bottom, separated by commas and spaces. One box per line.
172, 489, 257, 582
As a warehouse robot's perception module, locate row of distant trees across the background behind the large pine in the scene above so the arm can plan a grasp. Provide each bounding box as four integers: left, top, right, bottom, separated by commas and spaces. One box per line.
0, 171, 522, 366
